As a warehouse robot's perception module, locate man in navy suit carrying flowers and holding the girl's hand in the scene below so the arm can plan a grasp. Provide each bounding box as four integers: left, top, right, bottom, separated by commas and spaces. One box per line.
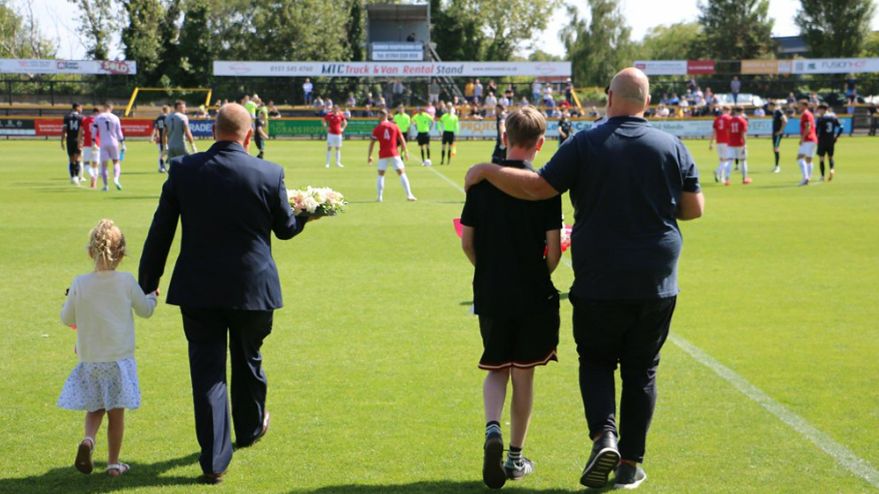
139, 103, 306, 484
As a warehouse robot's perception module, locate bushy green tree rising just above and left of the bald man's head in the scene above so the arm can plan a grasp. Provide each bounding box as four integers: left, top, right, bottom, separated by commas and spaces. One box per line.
559, 0, 633, 86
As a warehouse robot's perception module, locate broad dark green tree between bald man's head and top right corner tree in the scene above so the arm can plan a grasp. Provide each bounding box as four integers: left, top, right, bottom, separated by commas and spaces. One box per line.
698, 0, 774, 60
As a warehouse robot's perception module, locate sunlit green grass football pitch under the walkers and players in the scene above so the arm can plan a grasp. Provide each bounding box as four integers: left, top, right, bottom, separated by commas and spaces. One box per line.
0, 133, 879, 494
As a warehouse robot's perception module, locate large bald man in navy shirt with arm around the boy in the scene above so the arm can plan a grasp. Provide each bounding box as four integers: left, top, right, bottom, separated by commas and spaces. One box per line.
466, 68, 704, 488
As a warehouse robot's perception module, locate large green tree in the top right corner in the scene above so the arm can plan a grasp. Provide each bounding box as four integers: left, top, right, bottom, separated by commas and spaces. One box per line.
796, 0, 876, 58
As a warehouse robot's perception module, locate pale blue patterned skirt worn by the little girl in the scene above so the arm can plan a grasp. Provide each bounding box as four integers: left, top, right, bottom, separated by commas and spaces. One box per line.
58, 358, 140, 412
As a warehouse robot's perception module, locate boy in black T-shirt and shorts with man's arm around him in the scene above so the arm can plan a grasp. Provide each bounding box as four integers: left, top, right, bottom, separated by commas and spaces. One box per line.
461, 107, 562, 489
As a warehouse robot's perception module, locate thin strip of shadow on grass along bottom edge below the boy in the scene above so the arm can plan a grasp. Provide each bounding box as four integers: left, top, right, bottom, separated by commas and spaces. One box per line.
289, 480, 592, 494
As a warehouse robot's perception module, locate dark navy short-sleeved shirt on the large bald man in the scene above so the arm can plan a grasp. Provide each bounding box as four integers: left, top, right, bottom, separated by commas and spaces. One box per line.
540, 117, 701, 300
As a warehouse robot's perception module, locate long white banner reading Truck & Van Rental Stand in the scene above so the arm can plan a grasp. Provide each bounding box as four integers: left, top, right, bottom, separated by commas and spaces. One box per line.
214, 60, 572, 77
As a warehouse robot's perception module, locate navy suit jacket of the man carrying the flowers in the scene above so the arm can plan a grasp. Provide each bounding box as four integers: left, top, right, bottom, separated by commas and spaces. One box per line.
139, 141, 305, 310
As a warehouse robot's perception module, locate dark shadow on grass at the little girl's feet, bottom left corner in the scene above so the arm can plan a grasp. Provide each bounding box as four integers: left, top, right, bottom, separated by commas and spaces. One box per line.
0, 453, 198, 494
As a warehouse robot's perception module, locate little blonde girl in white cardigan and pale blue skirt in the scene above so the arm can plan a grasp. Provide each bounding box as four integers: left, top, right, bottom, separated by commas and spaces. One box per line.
58, 219, 158, 477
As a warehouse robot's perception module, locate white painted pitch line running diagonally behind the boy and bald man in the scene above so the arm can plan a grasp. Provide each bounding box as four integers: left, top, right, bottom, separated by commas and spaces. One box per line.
430, 168, 879, 489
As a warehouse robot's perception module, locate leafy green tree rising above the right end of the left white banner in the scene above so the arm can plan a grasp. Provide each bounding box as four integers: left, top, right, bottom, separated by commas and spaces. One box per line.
122, 0, 166, 85
